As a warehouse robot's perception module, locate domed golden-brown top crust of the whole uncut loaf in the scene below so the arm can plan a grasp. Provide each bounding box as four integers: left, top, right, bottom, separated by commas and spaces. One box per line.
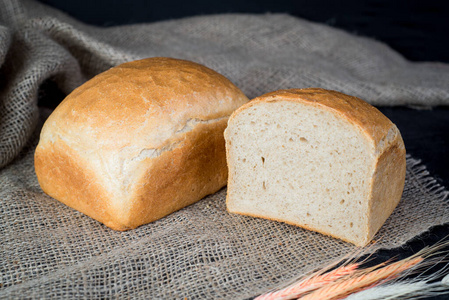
42, 57, 248, 149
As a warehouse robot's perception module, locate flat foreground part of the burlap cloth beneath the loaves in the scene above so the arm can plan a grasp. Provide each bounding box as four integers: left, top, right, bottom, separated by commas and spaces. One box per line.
0, 113, 449, 299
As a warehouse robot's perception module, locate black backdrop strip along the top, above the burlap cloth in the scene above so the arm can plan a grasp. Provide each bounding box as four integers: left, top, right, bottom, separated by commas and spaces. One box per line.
40, 0, 449, 62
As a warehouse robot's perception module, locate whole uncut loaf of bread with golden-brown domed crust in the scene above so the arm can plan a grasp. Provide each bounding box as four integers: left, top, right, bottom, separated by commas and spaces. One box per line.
35, 58, 248, 230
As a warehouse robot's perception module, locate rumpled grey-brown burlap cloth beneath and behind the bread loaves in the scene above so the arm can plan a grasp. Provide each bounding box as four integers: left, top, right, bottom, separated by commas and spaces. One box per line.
0, 0, 449, 299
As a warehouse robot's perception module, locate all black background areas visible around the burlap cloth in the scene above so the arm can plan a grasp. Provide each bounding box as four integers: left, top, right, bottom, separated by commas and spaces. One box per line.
36, 0, 449, 299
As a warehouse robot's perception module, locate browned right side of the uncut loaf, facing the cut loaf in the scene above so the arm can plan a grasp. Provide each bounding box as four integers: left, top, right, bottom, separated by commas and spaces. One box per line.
122, 119, 228, 228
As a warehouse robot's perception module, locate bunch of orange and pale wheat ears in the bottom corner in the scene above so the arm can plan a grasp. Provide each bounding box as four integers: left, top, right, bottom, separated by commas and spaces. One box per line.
255, 241, 449, 300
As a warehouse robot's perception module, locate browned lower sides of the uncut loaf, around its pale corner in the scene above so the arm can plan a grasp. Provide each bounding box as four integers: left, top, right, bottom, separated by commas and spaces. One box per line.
35, 119, 228, 231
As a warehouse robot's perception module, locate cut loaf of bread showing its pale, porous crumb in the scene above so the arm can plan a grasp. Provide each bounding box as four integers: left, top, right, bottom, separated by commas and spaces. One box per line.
225, 88, 405, 246
